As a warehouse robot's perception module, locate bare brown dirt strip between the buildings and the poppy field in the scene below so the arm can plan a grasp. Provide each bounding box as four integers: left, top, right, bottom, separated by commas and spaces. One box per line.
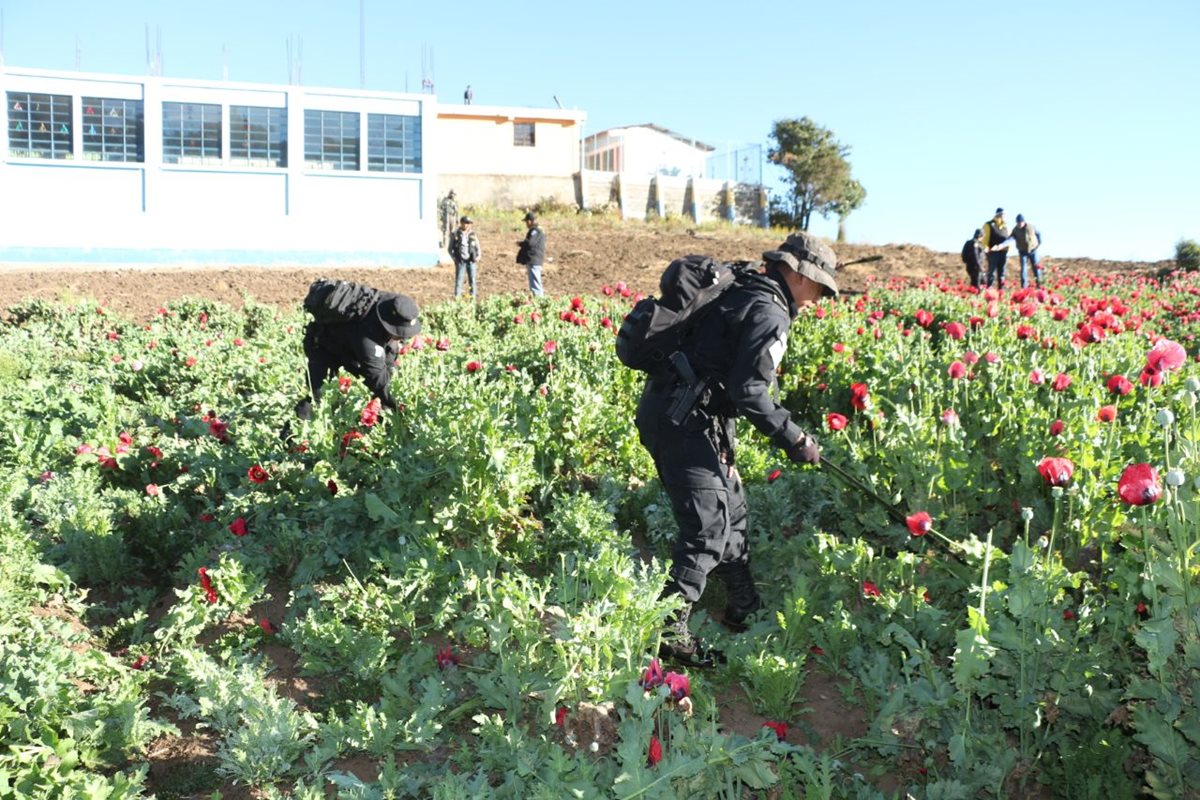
0, 217, 1171, 320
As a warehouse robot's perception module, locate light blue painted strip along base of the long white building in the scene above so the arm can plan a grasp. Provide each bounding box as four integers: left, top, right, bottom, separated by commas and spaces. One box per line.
0, 247, 438, 267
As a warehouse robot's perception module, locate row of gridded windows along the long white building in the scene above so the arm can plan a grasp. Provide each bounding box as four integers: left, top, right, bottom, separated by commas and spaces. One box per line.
7, 91, 427, 173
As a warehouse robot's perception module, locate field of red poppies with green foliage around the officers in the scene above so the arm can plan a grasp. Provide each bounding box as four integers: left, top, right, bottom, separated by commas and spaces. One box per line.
0, 271, 1200, 800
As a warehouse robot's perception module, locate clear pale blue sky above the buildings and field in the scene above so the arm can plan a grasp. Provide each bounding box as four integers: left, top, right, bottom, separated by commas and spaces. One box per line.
0, 0, 1200, 260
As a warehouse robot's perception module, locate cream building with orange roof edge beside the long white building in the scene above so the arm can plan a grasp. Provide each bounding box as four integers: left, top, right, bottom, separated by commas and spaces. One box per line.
430, 104, 587, 209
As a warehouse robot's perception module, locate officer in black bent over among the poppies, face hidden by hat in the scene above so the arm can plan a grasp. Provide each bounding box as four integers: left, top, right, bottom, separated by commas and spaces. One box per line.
295, 291, 421, 420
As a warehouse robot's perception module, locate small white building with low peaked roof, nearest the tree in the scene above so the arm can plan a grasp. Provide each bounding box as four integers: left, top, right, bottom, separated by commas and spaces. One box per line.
583, 125, 715, 178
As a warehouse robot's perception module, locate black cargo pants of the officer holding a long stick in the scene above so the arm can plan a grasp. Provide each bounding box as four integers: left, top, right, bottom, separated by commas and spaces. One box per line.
636, 380, 749, 603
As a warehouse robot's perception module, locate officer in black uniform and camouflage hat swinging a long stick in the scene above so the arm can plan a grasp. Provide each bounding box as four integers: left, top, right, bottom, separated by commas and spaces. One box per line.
637, 233, 838, 667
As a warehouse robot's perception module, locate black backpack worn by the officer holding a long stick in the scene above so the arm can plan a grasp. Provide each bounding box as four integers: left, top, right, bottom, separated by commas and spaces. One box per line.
617, 255, 750, 374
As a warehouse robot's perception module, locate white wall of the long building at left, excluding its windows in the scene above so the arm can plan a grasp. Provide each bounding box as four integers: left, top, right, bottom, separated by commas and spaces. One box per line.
0, 67, 446, 265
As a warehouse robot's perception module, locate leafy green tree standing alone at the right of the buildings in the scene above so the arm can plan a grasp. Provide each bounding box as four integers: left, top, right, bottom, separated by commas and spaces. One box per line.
767, 116, 866, 230
